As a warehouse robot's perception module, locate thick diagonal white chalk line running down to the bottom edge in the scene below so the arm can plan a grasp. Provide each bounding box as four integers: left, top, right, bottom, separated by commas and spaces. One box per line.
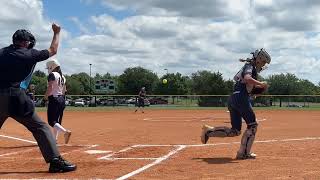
116, 145, 186, 180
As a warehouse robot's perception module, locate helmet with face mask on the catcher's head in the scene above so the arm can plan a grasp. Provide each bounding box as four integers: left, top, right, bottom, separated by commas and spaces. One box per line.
253, 49, 271, 73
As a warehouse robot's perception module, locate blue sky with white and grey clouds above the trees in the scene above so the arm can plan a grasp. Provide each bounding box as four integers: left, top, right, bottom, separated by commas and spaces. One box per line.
0, 0, 320, 84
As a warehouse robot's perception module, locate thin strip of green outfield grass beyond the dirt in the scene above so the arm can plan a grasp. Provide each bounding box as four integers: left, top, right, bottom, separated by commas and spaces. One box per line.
36, 105, 320, 112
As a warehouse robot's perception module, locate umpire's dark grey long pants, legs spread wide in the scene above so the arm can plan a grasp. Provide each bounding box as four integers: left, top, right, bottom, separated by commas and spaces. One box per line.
0, 88, 60, 163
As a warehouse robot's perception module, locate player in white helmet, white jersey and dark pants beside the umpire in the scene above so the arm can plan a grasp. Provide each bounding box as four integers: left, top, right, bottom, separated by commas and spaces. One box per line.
45, 60, 71, 144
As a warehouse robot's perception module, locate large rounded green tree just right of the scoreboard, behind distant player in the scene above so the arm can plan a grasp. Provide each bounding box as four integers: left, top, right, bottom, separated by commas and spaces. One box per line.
117, 67, 159, 94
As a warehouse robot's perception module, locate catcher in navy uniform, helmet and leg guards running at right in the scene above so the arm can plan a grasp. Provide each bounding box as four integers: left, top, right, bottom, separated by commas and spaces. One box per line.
201, 49, 271, 159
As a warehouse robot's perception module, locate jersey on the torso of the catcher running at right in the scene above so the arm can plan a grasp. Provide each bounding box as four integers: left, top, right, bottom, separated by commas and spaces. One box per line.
233, 63, 257, 93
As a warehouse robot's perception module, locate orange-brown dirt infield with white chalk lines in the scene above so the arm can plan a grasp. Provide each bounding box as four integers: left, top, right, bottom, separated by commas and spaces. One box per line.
0, 109, 320, 179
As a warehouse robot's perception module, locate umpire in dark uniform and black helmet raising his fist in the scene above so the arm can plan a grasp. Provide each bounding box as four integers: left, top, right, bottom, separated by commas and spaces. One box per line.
0, 23, 76, 173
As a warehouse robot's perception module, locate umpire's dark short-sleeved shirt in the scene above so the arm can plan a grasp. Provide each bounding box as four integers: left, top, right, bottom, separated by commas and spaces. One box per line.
0, 45, 49, 88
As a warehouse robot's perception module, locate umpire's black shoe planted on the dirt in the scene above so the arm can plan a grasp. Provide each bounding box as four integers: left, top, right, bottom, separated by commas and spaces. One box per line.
49, 156, 77, 173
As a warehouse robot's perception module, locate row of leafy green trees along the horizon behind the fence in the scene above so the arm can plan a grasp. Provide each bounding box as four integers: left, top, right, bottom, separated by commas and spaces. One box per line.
31, 67, 320, 95
